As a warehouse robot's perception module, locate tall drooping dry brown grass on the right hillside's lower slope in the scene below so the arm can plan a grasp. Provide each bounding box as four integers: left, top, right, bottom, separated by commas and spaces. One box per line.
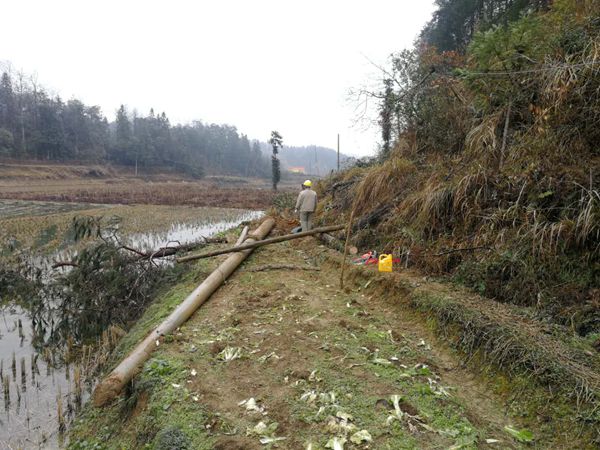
316, 130, 600, 332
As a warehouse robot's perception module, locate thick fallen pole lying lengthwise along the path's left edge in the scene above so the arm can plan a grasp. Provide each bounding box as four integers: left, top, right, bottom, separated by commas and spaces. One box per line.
94, 218, 275, 406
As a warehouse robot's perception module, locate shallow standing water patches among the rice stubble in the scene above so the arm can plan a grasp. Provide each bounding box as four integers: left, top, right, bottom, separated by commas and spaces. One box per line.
0, 201, 262, 449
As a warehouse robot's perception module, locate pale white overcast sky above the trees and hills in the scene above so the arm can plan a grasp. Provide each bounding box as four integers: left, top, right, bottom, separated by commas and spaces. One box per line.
0, 0, 433, 156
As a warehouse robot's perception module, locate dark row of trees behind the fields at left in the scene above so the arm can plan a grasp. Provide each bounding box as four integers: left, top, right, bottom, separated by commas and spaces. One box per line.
0, 70, 270, 177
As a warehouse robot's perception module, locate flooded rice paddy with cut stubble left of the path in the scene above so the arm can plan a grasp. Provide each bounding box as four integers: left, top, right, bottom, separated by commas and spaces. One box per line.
0, 200, 262, 449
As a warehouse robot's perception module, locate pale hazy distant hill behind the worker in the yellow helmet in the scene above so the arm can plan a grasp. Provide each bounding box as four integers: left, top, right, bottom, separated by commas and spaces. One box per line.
260, 142, 349, 176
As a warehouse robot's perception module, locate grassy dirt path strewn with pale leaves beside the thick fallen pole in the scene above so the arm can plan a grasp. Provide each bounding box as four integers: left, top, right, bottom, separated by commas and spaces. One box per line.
74, 238, 540, 449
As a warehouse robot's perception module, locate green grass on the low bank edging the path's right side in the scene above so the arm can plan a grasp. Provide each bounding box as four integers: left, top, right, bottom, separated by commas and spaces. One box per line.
406, 293, 600, 448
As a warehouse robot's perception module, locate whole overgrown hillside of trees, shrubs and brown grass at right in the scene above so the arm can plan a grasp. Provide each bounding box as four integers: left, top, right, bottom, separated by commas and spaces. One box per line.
321, 0, 600, 342
